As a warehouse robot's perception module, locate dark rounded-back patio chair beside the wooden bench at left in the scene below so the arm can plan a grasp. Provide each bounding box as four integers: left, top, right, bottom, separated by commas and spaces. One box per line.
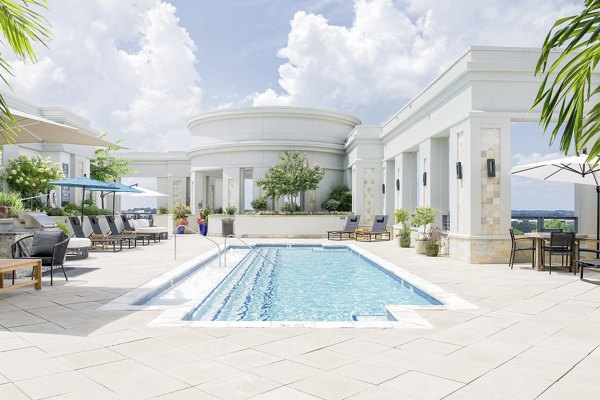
10, 231, 69, 286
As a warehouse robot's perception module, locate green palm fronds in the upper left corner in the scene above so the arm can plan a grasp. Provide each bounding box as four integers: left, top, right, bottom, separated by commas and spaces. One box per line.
0, 0, 50, 143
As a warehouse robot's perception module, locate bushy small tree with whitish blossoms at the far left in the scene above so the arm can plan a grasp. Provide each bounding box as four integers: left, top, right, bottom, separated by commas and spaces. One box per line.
2, 156, 64, 198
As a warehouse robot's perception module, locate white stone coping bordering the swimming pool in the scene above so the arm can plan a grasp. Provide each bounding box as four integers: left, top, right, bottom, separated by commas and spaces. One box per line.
99, 243, 477, 329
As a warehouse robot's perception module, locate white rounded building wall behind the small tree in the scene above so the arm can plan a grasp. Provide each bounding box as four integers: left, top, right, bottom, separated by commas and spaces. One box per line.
187, 107, 360, 211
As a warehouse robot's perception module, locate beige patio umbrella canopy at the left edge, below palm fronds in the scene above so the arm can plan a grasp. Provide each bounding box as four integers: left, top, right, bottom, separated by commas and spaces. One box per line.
0, 110, 125, 148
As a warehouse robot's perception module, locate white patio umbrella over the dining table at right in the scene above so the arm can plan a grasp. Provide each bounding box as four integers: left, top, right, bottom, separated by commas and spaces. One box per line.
510, 154, 600, 240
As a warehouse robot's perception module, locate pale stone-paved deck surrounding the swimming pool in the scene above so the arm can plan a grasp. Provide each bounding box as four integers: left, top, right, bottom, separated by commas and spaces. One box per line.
0, 235, 600, 400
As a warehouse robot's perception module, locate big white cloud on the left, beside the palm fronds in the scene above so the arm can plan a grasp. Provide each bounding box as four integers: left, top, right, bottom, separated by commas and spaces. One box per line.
6, 0, 202, 150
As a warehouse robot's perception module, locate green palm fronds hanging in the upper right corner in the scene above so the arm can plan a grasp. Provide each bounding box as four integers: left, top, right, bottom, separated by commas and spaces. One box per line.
532, 0, 600, 160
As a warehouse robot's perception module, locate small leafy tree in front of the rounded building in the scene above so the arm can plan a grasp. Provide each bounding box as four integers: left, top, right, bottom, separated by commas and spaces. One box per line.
256, 151, 325, 209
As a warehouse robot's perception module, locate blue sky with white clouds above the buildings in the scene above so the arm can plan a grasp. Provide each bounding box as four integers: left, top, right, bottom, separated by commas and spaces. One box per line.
3, 0, 583, 208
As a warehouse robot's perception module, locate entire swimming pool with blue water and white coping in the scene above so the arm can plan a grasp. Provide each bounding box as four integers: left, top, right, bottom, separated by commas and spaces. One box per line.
100, 243, 476, 329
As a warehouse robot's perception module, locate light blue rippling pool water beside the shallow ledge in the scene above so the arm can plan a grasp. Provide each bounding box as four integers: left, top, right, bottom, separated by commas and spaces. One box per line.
187, 245, 441, 321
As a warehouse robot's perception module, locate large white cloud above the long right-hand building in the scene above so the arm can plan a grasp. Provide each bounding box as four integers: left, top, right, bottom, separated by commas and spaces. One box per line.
254, 0, 582, 122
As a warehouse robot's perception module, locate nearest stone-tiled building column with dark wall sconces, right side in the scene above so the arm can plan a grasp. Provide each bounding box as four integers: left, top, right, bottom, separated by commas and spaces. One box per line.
449, 117, 511, 263
